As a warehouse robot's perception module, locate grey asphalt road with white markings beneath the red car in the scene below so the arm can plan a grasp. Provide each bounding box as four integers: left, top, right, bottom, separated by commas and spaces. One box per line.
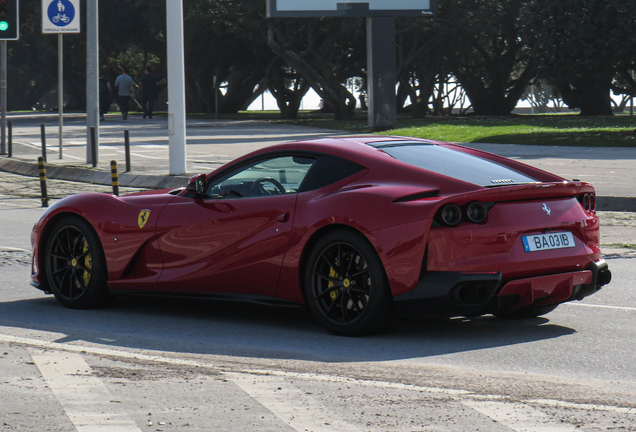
0, 174, 636, 432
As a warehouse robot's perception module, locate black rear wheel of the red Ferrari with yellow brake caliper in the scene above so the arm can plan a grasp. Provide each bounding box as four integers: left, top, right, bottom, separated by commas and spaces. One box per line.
303, 230, 394, 336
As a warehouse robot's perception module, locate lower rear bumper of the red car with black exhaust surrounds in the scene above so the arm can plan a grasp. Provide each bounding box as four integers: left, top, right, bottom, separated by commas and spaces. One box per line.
393, 260, 611, 316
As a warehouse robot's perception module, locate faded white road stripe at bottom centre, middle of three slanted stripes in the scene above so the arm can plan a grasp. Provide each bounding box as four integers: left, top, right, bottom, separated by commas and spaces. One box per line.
229, 372, 361, 432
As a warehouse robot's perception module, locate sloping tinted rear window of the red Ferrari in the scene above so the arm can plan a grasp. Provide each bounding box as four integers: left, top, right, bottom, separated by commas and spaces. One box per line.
378, 143, 537, 187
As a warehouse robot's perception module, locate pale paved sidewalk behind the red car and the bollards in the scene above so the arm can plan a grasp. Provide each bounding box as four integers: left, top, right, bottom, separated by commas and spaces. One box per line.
0, 114, 636, 212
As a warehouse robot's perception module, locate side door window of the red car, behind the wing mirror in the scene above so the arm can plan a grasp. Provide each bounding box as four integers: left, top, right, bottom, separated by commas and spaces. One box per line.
207, 156, 316, 198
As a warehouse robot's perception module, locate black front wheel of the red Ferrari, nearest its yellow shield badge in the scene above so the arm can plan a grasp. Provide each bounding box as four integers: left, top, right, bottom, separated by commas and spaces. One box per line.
44, 216, 110, 309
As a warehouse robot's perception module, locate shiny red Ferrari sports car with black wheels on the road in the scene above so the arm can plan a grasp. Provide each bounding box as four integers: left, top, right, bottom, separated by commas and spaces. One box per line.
32, 136, 611, 335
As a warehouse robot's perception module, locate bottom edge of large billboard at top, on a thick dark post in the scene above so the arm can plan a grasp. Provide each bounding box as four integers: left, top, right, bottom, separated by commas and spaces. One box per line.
267, 0, 437, 18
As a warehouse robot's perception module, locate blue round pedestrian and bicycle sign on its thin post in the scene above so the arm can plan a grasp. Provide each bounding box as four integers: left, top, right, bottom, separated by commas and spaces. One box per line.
41, 0, 80, 159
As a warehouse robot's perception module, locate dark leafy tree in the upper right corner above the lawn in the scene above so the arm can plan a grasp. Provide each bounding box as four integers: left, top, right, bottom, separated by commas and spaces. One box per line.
523, 0, 636, 115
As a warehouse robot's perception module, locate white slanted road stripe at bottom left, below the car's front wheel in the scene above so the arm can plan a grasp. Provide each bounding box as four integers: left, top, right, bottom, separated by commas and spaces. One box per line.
31, 353, 141, 432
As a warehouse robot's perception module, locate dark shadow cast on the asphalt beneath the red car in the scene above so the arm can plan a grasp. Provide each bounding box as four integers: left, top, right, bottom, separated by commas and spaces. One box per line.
0, 296, 575, 362
